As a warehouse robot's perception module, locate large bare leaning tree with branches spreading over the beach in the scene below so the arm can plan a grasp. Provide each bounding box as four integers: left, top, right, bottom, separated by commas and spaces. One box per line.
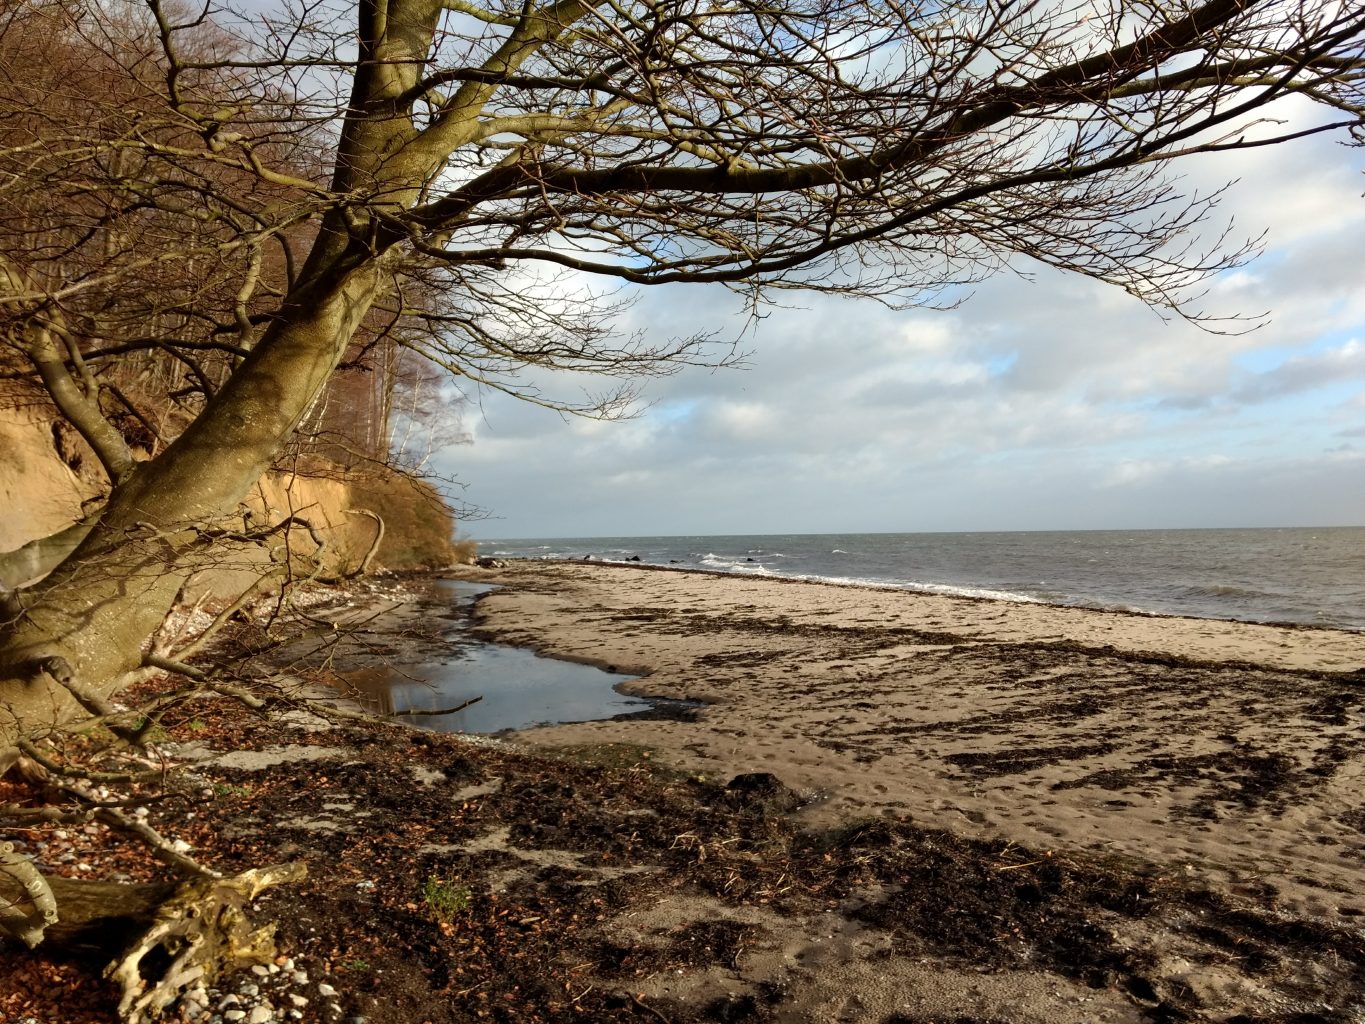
0, 0, 1365, 1010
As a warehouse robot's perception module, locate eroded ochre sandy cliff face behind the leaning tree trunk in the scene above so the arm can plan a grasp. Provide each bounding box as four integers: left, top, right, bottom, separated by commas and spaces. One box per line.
0, 407, 455, 572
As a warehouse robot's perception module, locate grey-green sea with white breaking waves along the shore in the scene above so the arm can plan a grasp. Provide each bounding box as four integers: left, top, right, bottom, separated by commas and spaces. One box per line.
479, 527, 1365, 629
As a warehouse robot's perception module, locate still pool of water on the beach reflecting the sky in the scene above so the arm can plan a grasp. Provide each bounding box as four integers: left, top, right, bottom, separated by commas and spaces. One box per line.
331, 580, 696, 733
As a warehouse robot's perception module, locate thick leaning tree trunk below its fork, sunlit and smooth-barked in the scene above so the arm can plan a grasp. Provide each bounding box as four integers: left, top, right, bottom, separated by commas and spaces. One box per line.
0, 251, 381, 752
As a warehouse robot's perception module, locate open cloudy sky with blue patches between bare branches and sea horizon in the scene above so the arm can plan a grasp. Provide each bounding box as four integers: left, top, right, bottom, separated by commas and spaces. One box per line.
430, 118, 1365, 539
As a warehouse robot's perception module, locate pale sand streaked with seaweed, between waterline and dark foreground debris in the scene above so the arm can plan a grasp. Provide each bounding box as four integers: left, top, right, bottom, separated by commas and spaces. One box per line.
466, 564, 1365, 923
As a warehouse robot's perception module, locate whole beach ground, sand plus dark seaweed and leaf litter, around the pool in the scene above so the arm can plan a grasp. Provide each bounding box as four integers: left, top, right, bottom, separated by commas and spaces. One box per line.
10, 563, 1365, 1024
